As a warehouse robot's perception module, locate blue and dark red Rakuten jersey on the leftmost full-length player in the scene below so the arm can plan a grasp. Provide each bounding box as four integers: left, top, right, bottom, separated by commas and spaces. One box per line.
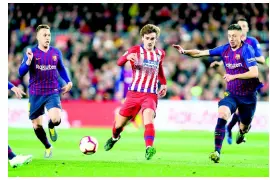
19, 46, 70, 95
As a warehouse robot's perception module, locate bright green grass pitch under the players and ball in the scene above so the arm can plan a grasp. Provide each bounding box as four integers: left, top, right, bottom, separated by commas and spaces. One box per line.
8, 128, 269, 177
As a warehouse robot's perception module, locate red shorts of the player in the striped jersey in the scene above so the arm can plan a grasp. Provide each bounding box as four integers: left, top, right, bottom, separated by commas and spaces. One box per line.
119, 91, 158, 117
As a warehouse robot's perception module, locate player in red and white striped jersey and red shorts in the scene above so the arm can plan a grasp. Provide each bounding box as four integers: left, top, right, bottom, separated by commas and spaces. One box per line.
104, 24, 167, 160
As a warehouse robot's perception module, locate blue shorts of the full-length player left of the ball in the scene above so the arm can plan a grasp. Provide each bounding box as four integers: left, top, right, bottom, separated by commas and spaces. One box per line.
29, 94, 62, 120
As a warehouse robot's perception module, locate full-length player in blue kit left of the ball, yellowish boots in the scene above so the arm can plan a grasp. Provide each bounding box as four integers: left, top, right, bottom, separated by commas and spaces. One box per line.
19, 24, 72, 158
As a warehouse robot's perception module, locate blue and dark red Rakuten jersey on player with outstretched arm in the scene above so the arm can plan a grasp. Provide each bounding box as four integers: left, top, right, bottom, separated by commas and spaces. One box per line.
209, 42, 261, 96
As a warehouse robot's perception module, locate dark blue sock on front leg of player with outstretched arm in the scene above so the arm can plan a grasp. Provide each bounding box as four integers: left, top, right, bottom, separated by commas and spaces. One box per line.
215, 118, 227, 153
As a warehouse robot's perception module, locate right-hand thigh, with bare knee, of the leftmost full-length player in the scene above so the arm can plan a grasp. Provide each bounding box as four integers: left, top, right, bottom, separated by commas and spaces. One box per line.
45, 94, 62, 122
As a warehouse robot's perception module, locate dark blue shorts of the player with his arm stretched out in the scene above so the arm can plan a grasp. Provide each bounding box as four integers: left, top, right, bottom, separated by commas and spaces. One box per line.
218, 91, 257, 125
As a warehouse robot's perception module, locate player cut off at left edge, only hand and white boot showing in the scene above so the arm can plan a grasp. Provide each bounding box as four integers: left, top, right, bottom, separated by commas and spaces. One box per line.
8, 82, 32, 168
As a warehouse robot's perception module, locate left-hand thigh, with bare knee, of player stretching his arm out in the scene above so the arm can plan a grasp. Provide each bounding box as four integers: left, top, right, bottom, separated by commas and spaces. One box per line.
218, 96, 237, 120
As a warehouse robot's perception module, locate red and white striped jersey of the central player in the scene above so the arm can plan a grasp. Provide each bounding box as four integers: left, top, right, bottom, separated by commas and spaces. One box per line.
117, 45, 166, 94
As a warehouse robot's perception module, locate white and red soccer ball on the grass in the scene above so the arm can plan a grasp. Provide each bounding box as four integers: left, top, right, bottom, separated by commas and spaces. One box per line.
80, 136, 98, 155
